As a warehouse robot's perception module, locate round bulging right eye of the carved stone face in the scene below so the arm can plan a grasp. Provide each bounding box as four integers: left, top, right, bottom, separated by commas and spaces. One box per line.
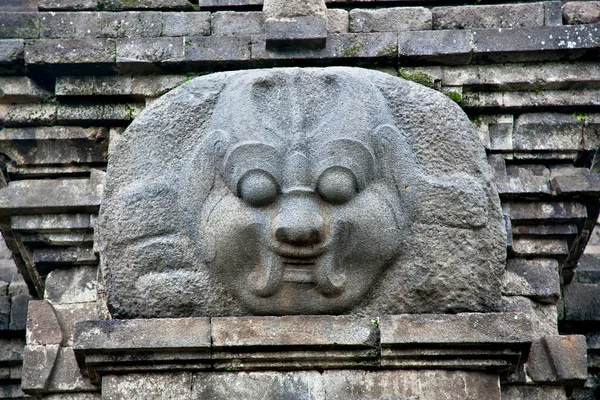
317, 167, 358, 204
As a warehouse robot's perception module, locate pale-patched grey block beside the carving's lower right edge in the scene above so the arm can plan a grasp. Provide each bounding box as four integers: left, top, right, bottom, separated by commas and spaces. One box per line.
502, 259, 560, 304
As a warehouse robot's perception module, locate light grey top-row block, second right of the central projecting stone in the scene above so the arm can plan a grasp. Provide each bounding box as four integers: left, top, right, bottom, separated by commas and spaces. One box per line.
349, 7, 431, 33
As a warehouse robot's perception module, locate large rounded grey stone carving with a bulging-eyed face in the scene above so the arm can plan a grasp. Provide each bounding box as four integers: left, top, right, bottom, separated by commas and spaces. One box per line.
99, 67, 505, 318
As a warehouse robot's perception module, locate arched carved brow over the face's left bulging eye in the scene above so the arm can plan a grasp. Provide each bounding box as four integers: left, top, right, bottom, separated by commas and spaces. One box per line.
222, 141, 283, 193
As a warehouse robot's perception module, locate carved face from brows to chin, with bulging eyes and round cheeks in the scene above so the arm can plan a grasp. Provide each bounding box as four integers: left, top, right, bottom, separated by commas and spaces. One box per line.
198, 130, 410, 314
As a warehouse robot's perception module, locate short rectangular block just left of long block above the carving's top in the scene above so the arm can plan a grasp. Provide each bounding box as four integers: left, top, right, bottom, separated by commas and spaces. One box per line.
184, 36, 251, 63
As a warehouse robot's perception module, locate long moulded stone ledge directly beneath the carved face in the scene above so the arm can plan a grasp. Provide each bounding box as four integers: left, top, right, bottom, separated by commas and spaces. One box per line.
74, 313, 533, 382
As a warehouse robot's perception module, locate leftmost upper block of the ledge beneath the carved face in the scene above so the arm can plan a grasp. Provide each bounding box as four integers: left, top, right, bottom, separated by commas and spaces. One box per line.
75, 318, 211, 355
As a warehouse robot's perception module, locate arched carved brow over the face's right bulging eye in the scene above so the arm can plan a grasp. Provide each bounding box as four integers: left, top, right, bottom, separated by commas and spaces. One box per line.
315, 139, 376, 190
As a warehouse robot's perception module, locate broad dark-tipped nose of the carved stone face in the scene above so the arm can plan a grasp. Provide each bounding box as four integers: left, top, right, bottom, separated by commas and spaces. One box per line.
275, 194, 324, 246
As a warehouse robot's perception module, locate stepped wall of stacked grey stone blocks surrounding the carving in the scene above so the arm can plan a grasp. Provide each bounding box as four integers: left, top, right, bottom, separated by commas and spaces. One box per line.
0, 0, 600, 400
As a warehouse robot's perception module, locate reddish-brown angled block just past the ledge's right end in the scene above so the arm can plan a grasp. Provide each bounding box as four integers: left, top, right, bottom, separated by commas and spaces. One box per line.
525, 335, 587, 385
